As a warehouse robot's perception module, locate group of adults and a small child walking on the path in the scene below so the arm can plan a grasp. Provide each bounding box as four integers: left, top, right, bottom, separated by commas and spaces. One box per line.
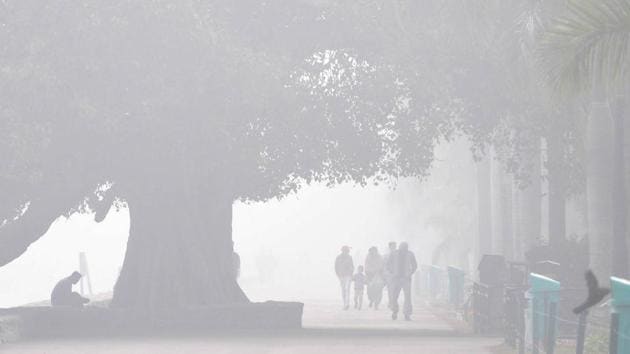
335, 242, 418, 321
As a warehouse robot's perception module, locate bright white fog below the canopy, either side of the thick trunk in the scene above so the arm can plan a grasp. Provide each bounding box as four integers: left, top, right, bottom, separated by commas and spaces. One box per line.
0, 139, 476, 307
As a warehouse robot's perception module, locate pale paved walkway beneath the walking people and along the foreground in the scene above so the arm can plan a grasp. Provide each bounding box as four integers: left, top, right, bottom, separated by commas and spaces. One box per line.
0, 301, 501, 354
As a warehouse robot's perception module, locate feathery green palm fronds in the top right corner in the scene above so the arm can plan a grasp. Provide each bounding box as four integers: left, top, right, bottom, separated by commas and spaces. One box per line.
539, 0, 630, 96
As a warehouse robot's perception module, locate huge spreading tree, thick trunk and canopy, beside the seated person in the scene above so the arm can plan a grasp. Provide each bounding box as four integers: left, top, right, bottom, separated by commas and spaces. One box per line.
0, 0, 464, 309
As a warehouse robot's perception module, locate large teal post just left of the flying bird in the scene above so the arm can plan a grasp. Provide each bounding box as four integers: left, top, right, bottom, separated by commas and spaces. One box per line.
529, 273, 560, 353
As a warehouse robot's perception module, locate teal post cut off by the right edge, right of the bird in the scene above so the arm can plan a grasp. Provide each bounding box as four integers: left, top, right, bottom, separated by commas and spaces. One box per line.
610, 277, 630, 354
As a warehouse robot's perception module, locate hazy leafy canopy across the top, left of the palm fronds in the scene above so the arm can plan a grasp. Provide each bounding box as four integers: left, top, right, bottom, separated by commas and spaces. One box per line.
0, 0, 604, 276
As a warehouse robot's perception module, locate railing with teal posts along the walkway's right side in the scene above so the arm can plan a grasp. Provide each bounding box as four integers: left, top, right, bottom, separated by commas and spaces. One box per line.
425, 267, 630, 354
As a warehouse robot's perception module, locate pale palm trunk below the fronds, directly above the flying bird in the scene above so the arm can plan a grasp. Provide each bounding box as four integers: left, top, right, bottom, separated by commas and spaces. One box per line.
586, 97, 613, 279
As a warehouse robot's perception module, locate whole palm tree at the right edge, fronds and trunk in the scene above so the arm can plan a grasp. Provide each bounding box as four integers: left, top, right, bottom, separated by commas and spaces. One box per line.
541, 0, 630, 276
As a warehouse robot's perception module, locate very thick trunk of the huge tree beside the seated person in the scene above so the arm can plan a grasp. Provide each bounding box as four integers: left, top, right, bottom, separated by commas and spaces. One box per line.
112, 191, 248, 311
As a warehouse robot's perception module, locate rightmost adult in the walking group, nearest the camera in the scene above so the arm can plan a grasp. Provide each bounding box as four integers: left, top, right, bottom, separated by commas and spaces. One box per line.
387, 242, 418, 321
